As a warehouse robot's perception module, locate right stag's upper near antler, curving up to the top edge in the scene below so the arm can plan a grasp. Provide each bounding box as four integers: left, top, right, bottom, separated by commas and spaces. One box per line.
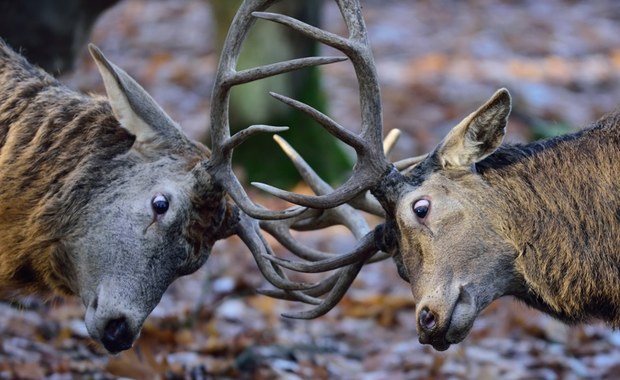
248, 0, 392, 209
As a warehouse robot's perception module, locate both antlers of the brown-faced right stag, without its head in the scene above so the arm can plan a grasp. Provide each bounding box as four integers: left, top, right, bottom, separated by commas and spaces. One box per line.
242, 0, 436, 319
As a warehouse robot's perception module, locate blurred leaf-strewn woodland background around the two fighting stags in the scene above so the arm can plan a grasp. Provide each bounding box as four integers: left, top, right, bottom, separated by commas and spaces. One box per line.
0, 0, 620, 379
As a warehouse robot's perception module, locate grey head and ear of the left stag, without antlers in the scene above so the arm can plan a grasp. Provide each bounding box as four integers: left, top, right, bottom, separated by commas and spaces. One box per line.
71, 45, 224, 352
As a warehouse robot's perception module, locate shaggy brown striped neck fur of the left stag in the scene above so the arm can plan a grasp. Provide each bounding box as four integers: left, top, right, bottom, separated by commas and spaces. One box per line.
0, 42, 134, 297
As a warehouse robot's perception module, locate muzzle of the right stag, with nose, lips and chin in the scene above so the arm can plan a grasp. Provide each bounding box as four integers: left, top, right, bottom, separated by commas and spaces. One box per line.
416, 285, 479, 351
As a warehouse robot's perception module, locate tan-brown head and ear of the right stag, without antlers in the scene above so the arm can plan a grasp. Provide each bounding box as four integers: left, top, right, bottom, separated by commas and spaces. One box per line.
377, 90, 515, 350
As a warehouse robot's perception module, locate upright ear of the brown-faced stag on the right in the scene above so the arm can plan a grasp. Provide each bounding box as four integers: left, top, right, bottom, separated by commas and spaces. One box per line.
433, 88, 511, 169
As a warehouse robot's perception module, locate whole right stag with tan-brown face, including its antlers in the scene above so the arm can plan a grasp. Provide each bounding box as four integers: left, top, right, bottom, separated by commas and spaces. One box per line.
251, 1, 620, 350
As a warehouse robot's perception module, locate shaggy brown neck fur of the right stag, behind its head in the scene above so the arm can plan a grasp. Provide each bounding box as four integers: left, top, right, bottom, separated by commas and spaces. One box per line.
477, 115, 620, 326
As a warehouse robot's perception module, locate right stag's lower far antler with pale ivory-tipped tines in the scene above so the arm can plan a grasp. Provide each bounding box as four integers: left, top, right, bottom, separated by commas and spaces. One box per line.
254, 130, 404, 319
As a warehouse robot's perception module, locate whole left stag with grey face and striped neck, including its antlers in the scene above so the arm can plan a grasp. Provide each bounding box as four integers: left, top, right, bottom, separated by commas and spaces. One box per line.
0, 1, 356, 353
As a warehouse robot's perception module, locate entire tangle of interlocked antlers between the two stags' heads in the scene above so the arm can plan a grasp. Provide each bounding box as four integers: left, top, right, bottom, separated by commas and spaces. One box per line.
212, 0, 426, 318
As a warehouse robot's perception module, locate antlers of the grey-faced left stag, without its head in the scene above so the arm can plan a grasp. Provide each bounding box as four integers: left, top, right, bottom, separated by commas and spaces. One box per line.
208, 0, 346, 292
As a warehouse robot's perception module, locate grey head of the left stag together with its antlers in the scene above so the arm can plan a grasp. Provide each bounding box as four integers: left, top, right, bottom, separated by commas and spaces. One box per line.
75, 23, 324, 352
